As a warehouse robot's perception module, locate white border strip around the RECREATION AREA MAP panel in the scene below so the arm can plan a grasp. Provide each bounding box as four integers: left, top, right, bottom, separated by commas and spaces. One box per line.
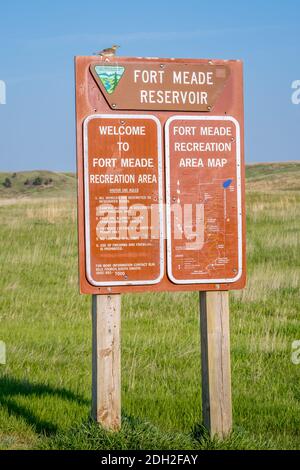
165, 115, 243, 284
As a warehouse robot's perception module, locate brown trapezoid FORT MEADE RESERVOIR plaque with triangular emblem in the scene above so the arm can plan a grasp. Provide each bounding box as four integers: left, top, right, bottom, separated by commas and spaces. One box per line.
90, 61, 230, 111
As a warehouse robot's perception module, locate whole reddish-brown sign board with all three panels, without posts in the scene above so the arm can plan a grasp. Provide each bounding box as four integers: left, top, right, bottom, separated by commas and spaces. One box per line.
75, 56, 245, 294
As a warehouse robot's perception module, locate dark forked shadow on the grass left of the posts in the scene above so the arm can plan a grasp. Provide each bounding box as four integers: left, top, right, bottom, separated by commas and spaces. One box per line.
0, 376, 88, 436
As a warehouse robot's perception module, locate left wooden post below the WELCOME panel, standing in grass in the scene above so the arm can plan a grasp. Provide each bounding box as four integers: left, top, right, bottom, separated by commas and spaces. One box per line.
92, 294, 121, 431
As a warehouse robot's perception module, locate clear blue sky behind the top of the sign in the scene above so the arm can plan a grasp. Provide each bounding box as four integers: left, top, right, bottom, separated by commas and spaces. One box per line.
0, 0, 300, 171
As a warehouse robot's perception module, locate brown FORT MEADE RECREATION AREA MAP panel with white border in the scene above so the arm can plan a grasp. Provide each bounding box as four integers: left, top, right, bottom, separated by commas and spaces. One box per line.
166, 116, 242, 284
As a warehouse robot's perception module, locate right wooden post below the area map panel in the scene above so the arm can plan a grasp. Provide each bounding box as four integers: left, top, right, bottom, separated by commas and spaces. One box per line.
200, 291, 232, 438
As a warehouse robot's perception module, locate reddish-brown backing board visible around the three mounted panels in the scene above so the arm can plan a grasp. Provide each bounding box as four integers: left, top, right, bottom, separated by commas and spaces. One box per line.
75, 56, 246, 295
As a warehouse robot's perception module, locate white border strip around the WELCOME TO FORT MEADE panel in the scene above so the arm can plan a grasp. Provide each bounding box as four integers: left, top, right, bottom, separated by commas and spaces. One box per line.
83, 114, 164, 287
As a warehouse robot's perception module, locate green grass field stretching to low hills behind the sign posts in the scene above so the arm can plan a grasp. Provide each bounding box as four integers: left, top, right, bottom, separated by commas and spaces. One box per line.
0, 163, 300, 449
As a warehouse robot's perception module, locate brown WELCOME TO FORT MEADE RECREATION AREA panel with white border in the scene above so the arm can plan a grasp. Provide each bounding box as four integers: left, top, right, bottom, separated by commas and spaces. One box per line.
84, 114, 164, 286
